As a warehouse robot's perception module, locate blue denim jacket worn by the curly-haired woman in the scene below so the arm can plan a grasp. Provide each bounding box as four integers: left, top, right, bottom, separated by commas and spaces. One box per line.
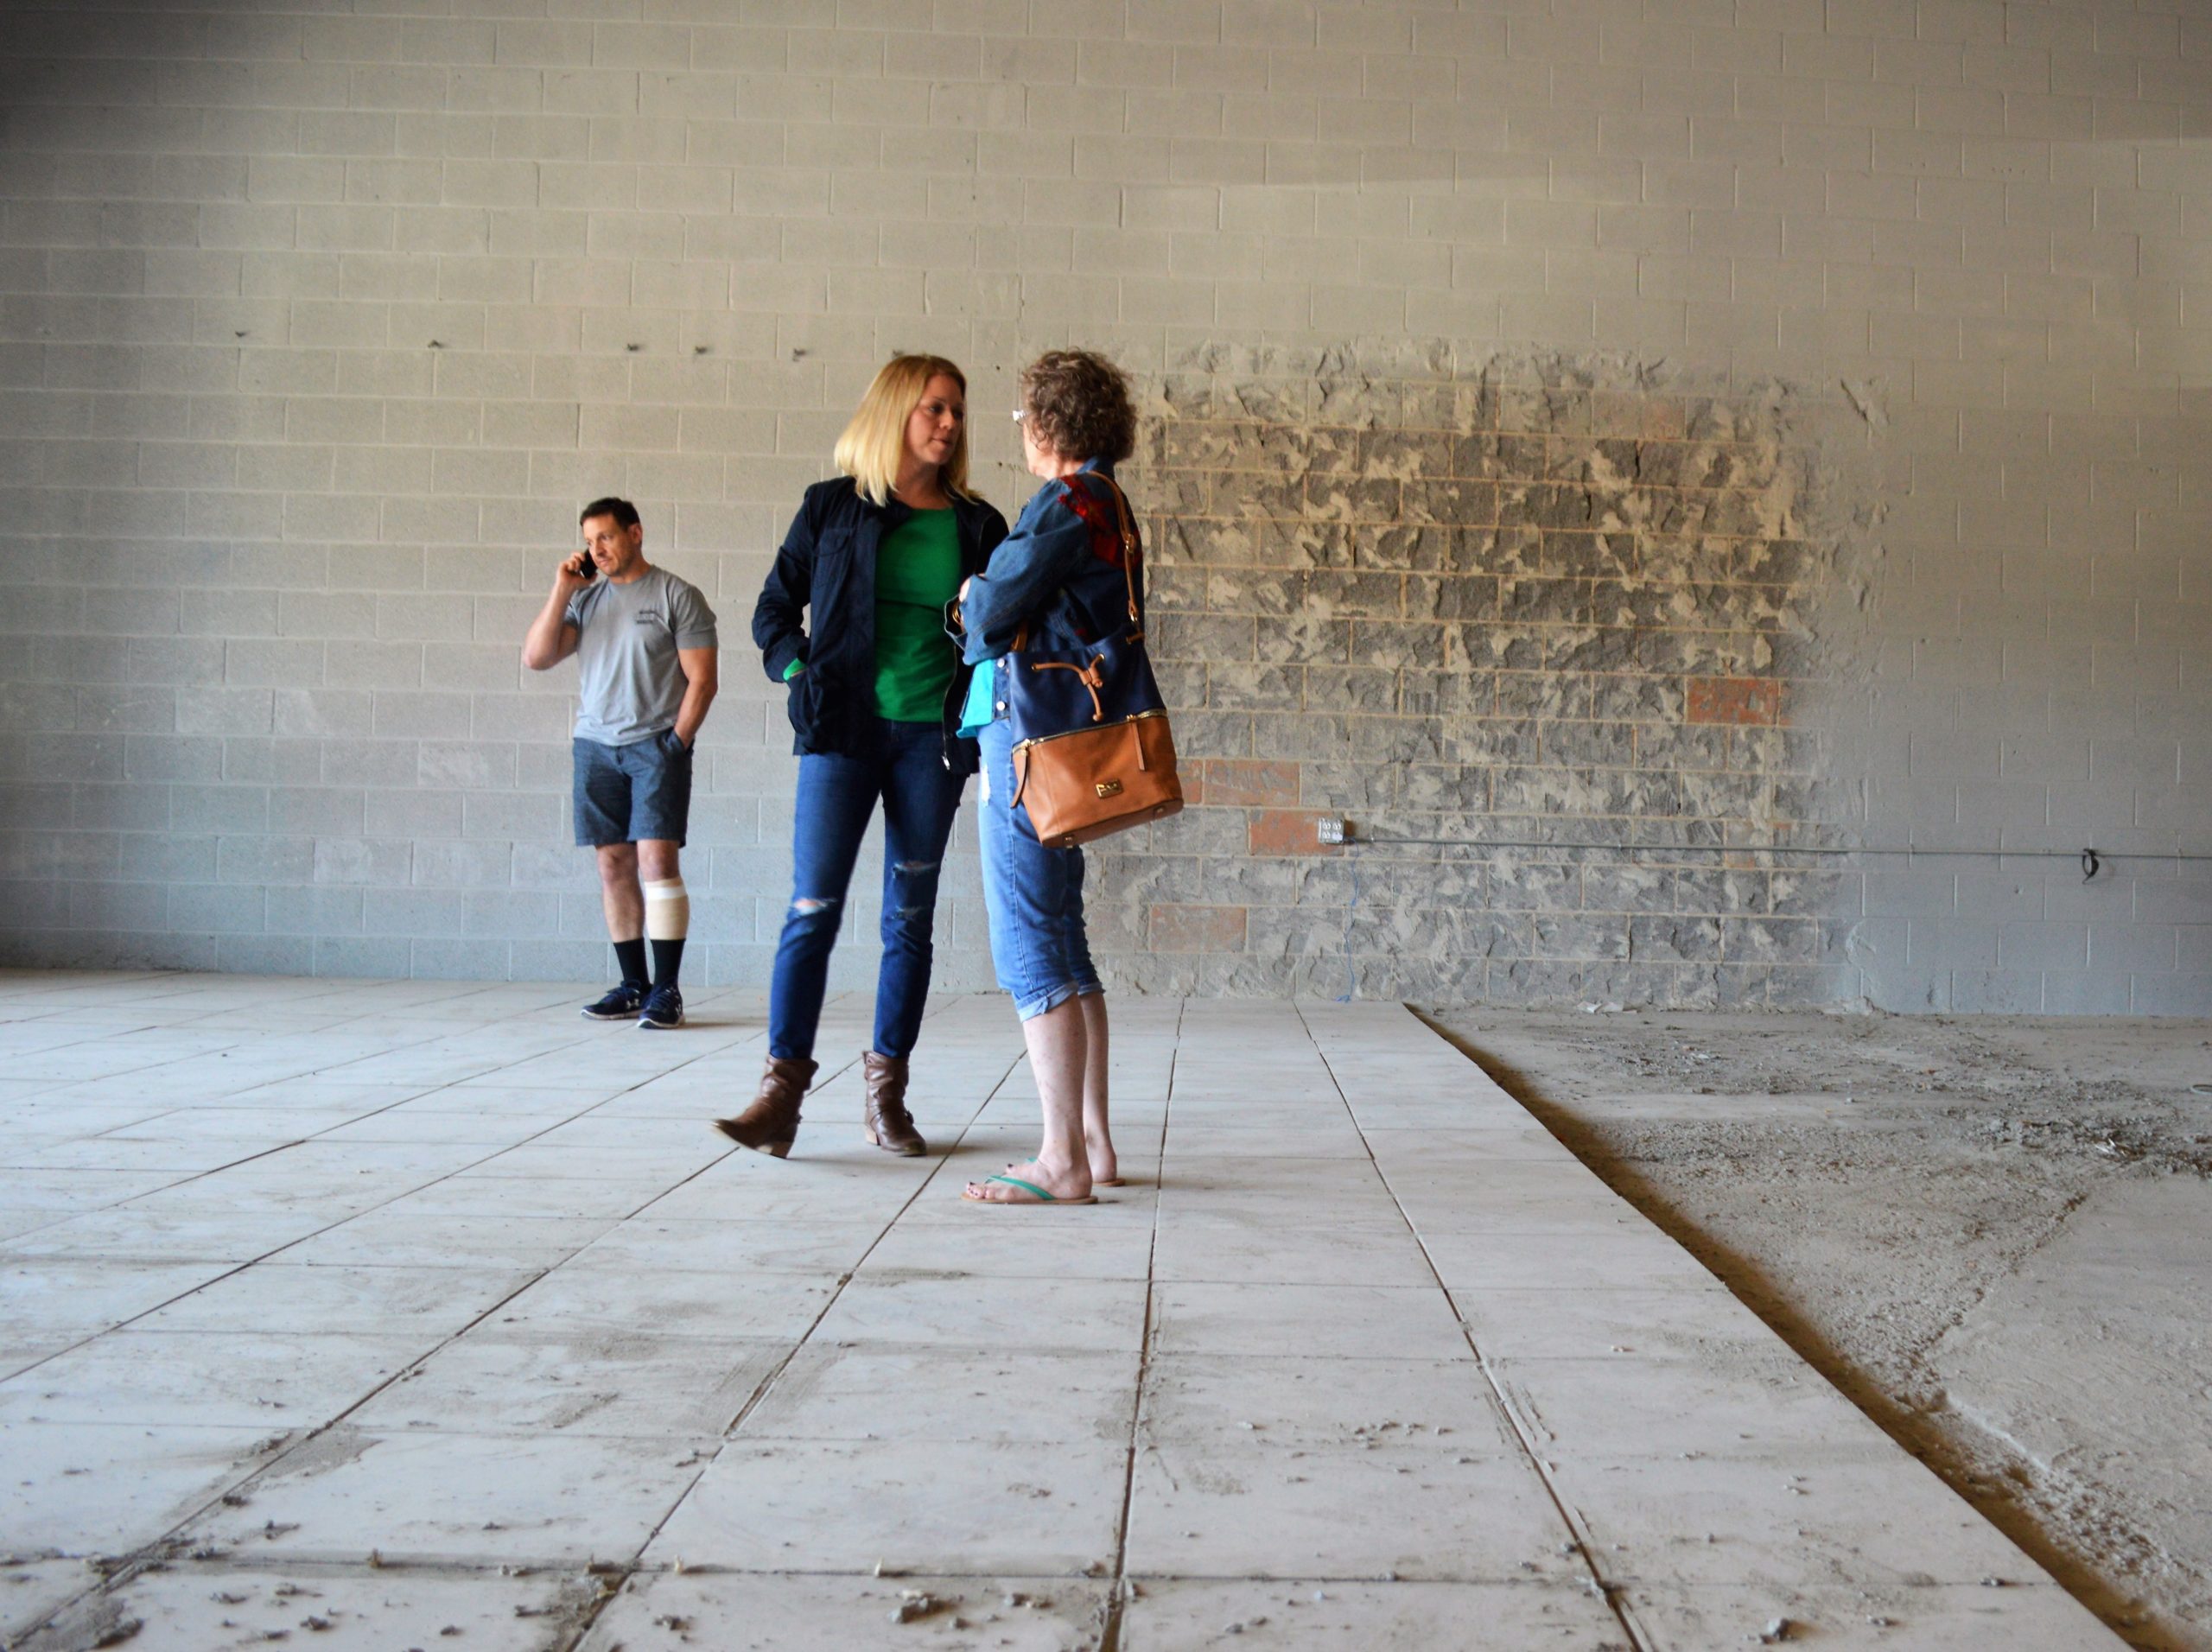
960, 460, 1144, 665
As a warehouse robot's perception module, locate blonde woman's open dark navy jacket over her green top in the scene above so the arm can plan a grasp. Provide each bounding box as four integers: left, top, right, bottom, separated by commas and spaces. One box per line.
752, 475, 1007, 774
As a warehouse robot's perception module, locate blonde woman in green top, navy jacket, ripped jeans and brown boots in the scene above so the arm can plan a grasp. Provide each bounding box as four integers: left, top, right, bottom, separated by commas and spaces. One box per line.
716, 356, 1007, 1159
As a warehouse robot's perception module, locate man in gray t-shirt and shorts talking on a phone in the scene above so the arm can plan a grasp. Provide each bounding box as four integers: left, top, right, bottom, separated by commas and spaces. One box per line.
522, 499, 716, 1028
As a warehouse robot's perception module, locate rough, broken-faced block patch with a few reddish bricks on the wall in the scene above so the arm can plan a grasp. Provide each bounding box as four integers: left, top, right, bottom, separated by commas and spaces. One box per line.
1093, 347, 1853, 1004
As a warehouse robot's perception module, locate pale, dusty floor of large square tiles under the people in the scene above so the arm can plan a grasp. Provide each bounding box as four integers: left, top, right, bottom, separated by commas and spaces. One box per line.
0, 975, 2123, 1652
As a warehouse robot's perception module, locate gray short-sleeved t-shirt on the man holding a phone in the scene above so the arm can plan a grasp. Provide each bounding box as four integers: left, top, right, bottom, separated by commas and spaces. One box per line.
562, 569, 715, 746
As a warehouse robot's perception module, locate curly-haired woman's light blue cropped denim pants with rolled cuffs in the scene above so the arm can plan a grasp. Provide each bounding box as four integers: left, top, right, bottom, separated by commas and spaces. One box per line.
976, 716, 1106, 1022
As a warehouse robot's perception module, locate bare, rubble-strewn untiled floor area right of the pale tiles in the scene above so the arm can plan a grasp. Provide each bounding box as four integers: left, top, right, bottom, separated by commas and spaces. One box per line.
1425, 1008, 2212, 1652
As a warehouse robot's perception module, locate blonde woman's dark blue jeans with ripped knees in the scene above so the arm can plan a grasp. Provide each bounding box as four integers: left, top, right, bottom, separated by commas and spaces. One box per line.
767, 719, 967, 1059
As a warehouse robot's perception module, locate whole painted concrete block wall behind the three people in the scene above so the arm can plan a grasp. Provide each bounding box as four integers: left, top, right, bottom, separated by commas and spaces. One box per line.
0, 0, 2212, 1013
